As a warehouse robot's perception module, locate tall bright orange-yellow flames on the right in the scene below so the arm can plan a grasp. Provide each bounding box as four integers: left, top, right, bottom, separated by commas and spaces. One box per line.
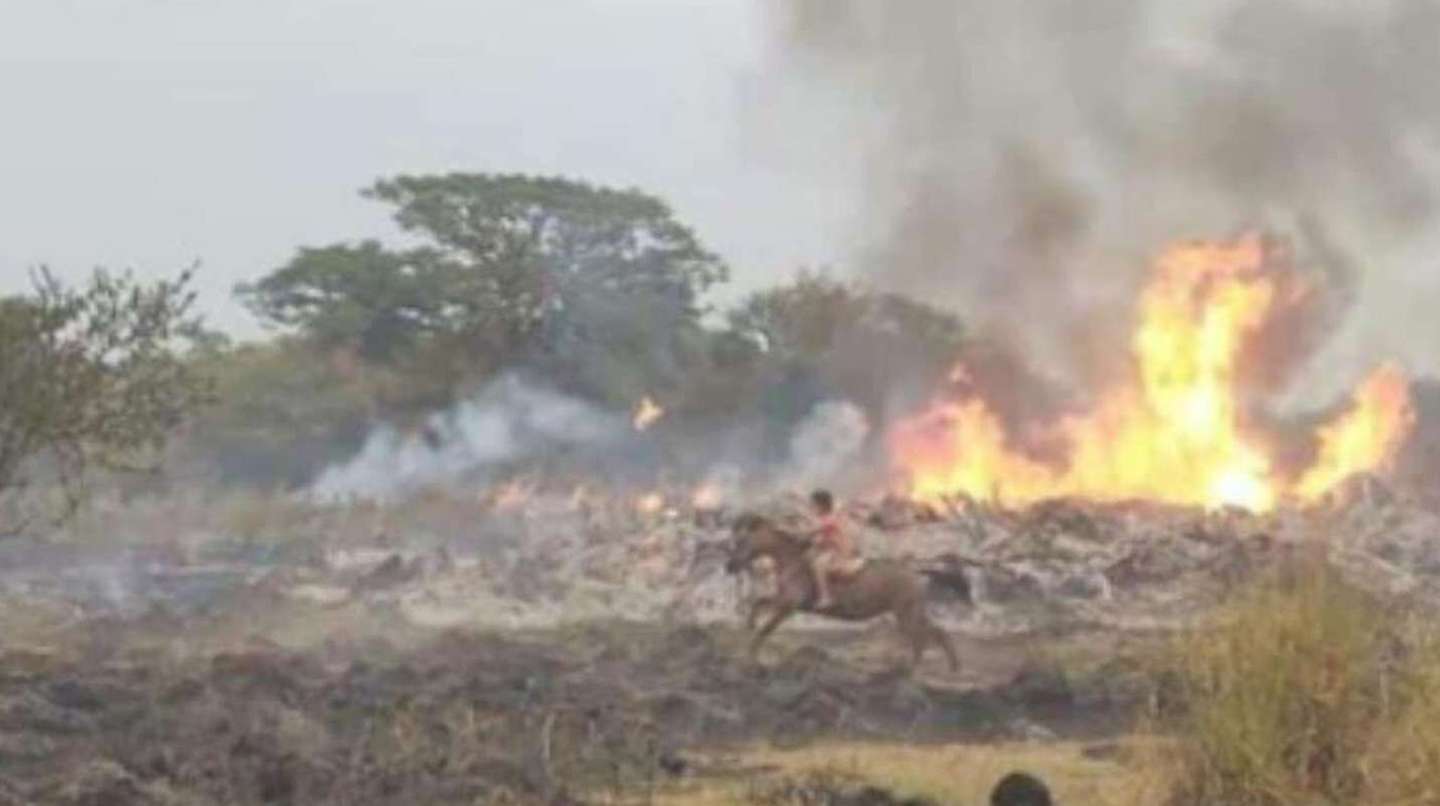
891, 237, 1414, 511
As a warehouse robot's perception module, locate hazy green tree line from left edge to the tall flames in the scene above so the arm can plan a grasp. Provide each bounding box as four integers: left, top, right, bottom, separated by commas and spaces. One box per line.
0, 173, 963, 518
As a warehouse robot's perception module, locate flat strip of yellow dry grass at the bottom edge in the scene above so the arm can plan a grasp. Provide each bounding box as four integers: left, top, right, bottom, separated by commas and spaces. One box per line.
655, 738, 1166, 806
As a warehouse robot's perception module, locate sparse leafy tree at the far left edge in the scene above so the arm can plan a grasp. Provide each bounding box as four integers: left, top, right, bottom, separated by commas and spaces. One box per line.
0, 269, 212, 530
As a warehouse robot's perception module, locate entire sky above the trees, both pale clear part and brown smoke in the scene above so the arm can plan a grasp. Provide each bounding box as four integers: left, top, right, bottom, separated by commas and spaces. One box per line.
11, 0, 1440, 394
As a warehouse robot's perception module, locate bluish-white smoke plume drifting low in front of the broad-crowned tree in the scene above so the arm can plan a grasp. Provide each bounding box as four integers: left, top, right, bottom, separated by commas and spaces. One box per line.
310, 376, 629, 499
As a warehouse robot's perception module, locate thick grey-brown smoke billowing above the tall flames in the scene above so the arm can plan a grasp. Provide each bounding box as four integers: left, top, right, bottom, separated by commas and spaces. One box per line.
752, 0, 1440, 391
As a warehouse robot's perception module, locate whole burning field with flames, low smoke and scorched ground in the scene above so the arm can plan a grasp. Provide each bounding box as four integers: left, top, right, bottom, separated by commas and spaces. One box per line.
8, 228, 1440, 805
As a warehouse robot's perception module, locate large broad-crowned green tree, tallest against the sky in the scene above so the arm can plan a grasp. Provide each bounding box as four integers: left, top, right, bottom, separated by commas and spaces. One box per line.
238, 174, 727, 405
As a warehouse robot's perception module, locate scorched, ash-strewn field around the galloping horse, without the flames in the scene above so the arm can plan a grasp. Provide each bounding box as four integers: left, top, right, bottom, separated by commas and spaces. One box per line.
0, 480, 1440, 806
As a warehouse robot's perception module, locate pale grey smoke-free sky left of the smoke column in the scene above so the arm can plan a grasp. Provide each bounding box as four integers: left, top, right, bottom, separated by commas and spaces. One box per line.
0, 0, 847, 337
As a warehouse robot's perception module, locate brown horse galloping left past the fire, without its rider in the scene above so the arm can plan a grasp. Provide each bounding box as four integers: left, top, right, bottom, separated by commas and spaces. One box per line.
726, 512, 960, 672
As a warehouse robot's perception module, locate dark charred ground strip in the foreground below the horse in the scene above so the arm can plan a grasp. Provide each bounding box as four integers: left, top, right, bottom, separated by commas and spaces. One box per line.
0, 615, 1140, 806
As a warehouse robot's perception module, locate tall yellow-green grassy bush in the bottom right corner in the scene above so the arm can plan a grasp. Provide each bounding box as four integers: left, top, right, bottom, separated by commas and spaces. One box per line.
1166, 563, 1440, 806
